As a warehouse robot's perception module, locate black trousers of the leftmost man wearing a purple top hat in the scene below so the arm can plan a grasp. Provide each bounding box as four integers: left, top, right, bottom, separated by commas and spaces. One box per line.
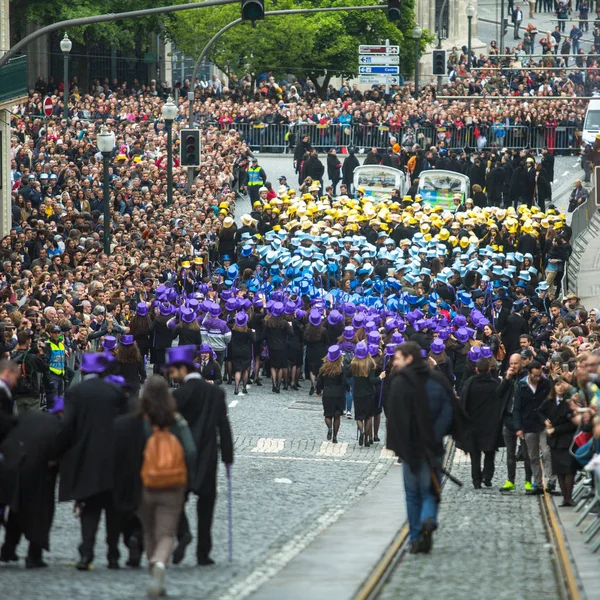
79, 492, 121, 562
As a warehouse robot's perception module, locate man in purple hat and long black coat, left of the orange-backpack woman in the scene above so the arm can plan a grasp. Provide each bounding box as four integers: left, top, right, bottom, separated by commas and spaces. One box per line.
57, 353, 127, 571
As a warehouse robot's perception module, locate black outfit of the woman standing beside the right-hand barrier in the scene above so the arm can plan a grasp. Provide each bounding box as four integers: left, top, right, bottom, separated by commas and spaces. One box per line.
539, 398, 579, 475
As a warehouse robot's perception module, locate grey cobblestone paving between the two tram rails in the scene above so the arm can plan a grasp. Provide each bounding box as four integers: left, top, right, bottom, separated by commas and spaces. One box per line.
378, 452, 560, 600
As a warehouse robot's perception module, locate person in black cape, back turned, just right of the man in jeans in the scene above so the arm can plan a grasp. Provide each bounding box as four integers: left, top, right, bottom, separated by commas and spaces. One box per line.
460, 358, 502, 489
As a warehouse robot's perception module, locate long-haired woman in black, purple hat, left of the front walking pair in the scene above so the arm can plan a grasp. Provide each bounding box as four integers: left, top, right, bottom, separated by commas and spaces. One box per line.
316, 345, 349, 444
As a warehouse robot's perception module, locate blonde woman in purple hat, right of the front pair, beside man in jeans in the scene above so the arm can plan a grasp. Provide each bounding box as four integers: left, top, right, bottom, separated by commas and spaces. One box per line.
350, 342, 381, 447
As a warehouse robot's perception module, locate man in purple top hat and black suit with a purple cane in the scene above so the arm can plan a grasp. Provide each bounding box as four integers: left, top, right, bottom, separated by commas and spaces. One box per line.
167, 346, 233, 565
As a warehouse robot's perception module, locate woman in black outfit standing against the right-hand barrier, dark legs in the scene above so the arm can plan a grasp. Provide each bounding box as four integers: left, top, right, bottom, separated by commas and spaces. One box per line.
539, 376, 579, 506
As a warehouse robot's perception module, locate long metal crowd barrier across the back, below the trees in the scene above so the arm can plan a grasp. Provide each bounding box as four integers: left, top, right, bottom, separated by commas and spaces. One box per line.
206, 123, 581, 153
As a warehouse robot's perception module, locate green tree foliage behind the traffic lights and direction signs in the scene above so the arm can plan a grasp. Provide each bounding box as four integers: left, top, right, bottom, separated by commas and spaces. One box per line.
166, 0, 430, 94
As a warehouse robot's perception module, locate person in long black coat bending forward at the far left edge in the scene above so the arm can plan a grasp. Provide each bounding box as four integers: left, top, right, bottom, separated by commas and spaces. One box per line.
0, 411, 61, 569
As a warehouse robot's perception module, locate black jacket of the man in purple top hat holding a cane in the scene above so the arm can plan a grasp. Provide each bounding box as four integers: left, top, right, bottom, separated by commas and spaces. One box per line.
173, 379, 233, 495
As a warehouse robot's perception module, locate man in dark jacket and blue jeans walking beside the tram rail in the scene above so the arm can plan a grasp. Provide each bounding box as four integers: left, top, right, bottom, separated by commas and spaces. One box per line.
386, 342, 454, 554
